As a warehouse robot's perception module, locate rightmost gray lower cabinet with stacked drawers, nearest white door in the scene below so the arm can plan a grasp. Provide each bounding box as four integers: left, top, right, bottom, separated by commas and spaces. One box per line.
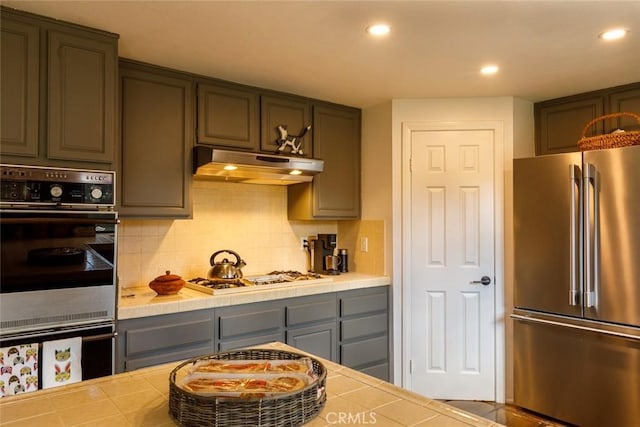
338, 286, 389, 380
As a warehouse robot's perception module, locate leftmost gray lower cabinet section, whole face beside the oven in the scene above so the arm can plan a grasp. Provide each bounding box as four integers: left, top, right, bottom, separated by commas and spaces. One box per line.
116, 309, 216, 372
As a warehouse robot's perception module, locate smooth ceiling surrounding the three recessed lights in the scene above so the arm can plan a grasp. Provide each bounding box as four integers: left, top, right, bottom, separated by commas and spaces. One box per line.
2, 0, 640, 108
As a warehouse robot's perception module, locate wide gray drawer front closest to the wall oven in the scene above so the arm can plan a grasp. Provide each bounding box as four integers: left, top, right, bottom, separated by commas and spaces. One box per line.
125, 319, 213, 356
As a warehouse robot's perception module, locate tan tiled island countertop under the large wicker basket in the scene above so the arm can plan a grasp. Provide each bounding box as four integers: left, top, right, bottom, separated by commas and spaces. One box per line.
0, 342, 500, 427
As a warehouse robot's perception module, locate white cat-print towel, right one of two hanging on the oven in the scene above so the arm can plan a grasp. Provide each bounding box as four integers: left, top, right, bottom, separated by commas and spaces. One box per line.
41, 337, 82, 388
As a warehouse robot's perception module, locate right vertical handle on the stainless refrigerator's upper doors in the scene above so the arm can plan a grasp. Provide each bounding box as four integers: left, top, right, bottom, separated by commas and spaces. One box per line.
583, 163, 599, 308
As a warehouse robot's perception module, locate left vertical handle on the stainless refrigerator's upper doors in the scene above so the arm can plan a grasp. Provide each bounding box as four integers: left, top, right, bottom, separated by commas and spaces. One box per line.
569, 164, 582, 306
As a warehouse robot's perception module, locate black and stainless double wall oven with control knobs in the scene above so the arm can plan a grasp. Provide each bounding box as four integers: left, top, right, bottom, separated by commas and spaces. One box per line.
0, 164, 118, 383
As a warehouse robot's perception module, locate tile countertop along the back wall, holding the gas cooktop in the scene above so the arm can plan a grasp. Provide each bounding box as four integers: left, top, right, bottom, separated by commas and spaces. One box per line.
118, 273, 391, 320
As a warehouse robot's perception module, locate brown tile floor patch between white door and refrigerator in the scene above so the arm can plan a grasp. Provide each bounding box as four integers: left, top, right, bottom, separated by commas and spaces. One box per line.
444, 400, 568, 427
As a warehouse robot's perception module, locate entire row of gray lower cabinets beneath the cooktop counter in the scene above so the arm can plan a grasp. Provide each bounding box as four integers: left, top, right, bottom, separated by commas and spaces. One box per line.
116, 286, 389, 380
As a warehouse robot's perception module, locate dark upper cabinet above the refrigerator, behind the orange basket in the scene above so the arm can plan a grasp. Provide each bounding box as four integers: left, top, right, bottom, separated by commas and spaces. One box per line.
534, 83, 640, 155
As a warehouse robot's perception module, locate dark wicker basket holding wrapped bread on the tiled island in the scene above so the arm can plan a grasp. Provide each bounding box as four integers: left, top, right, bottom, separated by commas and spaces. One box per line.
169, 349, 327, 427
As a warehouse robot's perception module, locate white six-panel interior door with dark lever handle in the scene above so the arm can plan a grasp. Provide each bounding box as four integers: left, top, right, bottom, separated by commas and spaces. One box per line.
403, 123, 496, 400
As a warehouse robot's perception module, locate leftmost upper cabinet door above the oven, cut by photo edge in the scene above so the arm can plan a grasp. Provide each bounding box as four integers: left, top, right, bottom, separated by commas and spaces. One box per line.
0, 16, 40, 157
